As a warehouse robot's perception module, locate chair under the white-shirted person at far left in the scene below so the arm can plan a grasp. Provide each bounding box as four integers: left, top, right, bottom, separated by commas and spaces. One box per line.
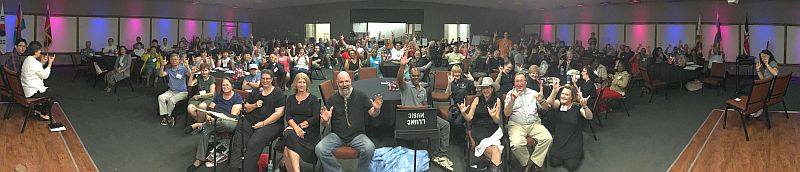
3, 68, 53, 133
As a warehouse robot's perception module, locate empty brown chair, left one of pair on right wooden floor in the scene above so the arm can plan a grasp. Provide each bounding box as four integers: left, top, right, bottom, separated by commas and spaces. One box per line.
722, 78, 773, 141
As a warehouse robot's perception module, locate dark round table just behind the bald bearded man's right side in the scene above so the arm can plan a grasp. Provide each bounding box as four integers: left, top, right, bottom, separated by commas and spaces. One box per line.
353, 78, 400, 127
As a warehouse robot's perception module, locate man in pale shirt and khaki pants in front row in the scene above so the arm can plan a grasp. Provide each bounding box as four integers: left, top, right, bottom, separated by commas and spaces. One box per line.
503, 73, 553, 171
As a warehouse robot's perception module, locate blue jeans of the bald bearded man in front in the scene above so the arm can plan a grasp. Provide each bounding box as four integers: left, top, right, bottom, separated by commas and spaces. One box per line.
314, 133, 375, 172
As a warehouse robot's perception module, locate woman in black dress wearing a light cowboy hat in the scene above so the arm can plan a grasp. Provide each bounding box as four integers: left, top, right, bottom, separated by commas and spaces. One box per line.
458, 77, 503, 171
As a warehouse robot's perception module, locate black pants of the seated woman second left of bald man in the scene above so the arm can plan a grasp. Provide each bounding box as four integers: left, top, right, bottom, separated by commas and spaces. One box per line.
231, 117, 283, 172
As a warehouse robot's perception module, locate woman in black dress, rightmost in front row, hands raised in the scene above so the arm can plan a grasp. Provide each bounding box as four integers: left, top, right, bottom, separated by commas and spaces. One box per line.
547, 82, 592, 171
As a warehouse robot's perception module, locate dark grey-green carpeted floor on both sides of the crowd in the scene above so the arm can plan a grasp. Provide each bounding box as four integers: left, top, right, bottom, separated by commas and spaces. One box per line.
28, 67, 800, 171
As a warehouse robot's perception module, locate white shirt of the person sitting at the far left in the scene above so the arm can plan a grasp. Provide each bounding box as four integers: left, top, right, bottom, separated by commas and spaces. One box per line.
20, 56, 50, 97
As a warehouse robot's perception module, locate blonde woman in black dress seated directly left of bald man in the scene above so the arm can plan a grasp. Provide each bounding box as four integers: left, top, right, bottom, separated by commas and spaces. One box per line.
283, 73, 320, 172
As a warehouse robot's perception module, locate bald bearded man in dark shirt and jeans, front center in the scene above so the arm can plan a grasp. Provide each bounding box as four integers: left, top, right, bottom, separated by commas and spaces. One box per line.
314, 72, 383, 172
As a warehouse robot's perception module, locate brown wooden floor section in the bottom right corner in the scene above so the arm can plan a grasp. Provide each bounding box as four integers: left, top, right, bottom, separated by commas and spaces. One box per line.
669, 110, 800, 172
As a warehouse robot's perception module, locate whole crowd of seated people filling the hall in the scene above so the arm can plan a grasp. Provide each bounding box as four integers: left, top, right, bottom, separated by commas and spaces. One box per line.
0, 24, 778, 171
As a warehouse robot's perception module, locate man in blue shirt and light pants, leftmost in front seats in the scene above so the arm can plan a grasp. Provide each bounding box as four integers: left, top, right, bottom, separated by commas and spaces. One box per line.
158, 53, 194, 127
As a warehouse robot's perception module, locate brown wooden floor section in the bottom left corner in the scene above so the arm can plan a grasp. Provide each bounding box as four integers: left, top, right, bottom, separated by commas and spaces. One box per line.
0, 103, 97, 171
